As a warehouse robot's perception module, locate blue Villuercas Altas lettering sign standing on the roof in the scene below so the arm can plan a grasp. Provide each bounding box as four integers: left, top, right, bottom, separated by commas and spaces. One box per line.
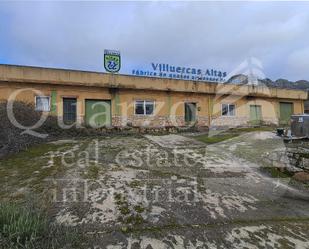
132, 63, 227, 82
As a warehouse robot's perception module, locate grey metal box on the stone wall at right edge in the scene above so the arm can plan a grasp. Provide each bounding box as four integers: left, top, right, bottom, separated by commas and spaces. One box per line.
291, 114, 309, 138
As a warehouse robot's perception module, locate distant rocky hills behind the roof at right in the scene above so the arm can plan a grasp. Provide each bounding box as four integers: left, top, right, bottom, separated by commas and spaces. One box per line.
226, 74, 309, 91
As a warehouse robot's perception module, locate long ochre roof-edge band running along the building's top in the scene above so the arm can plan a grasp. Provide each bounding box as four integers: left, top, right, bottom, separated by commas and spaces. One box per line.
0, 64, 308, 100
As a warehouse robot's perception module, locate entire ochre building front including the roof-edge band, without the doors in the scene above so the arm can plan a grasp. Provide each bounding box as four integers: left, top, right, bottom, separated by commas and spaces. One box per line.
0, 65, 307, 127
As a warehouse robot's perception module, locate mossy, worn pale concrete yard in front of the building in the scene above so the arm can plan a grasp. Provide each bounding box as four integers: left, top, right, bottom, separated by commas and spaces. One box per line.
0, 131, 309, 249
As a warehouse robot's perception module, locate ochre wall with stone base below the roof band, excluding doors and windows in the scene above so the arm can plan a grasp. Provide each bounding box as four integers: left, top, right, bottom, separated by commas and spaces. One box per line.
0, 82, 304, 127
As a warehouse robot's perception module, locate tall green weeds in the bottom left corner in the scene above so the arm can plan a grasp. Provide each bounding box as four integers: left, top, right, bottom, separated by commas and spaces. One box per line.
0, 203, 84, 249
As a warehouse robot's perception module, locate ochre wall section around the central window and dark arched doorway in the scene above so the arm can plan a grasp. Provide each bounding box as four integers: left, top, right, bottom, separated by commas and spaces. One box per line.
113, 90, 210, 126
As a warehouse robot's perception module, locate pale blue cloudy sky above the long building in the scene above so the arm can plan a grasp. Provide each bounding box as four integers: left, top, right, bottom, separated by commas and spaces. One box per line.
0, 1, 309, 80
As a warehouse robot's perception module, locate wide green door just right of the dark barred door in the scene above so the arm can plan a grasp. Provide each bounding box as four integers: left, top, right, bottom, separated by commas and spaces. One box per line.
85, 100, 111, 128
